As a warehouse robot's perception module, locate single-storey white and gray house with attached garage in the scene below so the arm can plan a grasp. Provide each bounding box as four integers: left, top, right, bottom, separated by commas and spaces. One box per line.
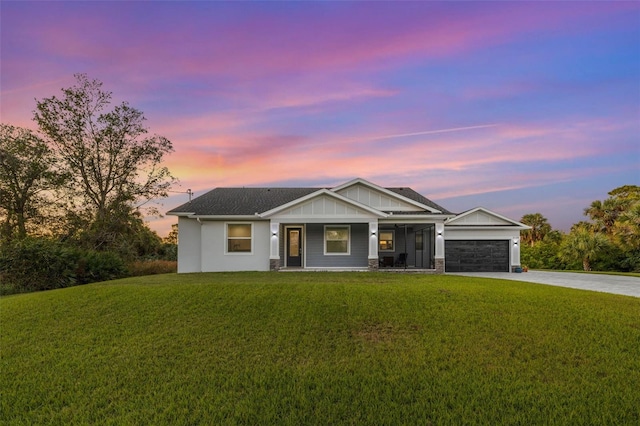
167, 179, 528, 273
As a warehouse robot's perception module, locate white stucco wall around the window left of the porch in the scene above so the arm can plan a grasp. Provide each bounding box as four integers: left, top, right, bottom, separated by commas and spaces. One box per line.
200, 221, 271, 272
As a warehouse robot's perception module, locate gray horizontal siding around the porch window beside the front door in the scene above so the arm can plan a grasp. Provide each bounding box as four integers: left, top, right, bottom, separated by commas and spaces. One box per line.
306, 223, 369, 268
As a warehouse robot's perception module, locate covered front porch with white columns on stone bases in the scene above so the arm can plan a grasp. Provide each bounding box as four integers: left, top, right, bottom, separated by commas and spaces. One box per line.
270, 220, 444, 273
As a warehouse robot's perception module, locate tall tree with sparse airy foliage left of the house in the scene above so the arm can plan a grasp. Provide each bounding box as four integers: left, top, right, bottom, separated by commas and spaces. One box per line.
34, 74, 175, 248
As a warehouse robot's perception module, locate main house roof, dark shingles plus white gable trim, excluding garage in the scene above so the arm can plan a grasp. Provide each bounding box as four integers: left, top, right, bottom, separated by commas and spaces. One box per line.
167, 179, 453, 216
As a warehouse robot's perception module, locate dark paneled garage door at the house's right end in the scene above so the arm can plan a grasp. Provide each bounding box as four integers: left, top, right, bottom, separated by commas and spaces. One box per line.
444, 240, 510, 272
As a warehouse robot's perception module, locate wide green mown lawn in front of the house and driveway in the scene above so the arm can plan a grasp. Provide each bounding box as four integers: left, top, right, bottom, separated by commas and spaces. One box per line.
0, 273, 640, 425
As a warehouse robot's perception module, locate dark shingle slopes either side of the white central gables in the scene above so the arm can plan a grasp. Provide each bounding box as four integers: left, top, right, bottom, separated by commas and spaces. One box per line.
167, 188, 451, 216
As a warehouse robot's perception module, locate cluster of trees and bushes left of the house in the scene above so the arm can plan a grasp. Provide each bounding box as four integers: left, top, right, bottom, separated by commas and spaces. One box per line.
0, 74, 176, 291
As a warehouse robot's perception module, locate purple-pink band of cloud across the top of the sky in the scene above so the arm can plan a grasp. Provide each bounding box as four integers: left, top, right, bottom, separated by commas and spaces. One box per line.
8, 2, 634, 84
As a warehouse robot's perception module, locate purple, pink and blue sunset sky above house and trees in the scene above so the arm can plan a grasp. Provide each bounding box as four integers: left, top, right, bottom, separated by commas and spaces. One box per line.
0, 0, 640, 236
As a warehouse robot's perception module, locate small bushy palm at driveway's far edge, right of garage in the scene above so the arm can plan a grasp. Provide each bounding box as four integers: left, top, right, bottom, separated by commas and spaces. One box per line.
560, 224, 610, 271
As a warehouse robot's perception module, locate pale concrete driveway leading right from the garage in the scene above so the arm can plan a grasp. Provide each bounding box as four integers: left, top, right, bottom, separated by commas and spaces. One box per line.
448, 271, 640, 297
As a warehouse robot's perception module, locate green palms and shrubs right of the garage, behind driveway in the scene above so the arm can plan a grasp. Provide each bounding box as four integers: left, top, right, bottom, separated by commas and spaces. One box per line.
521, 185, 640, 272
